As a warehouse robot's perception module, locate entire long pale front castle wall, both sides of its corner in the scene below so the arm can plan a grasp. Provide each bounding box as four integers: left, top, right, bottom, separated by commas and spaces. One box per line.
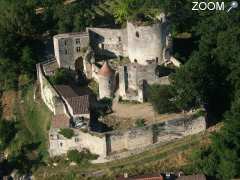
49, 114, 206, 163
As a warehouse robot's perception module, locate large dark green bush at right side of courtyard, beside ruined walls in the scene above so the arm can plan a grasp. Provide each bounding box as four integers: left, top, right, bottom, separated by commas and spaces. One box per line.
148, 85, 177, 114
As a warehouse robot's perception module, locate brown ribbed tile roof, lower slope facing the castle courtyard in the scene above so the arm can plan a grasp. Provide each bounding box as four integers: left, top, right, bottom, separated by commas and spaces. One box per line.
66, 95, 89, 114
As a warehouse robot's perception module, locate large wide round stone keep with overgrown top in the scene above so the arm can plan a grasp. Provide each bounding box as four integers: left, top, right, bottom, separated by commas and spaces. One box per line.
127, 18, 167, 65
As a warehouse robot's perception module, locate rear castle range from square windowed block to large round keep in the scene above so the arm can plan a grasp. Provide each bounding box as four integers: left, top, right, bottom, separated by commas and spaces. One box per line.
54, 13, 172, 69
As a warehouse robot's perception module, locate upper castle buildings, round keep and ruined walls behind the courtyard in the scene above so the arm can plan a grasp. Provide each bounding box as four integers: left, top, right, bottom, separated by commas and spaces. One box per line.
53, 14, 175, 102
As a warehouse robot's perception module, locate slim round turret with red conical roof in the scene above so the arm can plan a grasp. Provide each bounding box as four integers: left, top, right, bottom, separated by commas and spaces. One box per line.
98, 61, 114, 99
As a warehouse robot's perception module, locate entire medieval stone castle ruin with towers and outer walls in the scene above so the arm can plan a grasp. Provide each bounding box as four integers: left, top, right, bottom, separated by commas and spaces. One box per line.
37, 15, 206, 161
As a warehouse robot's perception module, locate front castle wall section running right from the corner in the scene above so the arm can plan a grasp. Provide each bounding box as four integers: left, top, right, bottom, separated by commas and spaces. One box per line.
106, 117, 206, 155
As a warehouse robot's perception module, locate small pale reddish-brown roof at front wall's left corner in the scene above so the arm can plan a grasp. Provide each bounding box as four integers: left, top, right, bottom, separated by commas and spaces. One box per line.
52, 114, 70, 128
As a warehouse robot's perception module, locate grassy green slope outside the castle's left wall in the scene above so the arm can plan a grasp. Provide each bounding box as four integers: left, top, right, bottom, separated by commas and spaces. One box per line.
11, 86, 52, 161
